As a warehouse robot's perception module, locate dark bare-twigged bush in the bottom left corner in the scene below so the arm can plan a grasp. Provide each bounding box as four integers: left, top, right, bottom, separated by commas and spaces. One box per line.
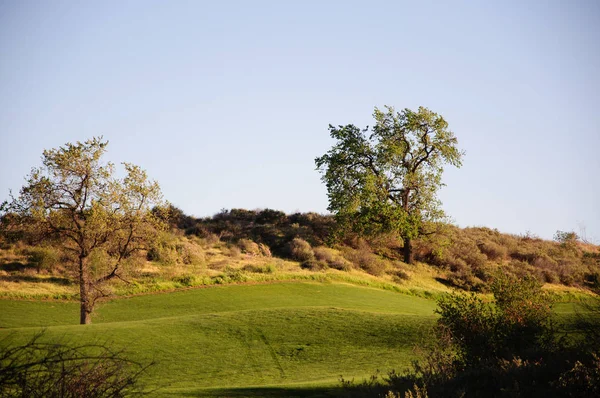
0, 333, 150, 398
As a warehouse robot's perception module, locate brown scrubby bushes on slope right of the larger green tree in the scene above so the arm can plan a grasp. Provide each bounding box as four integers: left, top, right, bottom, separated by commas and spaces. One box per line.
415, 226, 600, 290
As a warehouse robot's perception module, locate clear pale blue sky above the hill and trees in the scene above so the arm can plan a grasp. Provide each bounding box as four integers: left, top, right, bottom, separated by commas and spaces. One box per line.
0, 0, 600, 243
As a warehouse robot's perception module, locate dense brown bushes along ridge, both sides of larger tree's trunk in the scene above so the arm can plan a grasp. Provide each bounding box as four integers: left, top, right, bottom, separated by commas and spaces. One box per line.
151, 209, 600, 291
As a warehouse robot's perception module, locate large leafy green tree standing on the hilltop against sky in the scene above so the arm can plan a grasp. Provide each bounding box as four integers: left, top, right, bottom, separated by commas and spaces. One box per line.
315, 106, 464, 263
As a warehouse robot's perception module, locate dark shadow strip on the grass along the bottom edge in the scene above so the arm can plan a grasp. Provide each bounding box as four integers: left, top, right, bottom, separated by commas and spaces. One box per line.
176, 387, 349, 398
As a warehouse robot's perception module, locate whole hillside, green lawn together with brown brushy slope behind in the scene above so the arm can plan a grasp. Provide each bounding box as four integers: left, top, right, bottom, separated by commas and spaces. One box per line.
0, 209, 600, 397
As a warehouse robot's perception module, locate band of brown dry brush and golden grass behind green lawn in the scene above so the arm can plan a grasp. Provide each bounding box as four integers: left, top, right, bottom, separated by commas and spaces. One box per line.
0, 209, 600, 298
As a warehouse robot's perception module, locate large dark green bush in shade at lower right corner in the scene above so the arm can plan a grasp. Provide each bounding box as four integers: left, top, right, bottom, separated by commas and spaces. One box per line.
352, 274, 600, 398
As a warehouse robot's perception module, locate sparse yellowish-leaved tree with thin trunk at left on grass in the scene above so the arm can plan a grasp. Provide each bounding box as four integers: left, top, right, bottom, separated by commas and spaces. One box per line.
0, 137, 161, 324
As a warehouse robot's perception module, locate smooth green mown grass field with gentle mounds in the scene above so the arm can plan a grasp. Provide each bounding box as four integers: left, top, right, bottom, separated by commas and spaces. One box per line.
0, 282, 435, 396
